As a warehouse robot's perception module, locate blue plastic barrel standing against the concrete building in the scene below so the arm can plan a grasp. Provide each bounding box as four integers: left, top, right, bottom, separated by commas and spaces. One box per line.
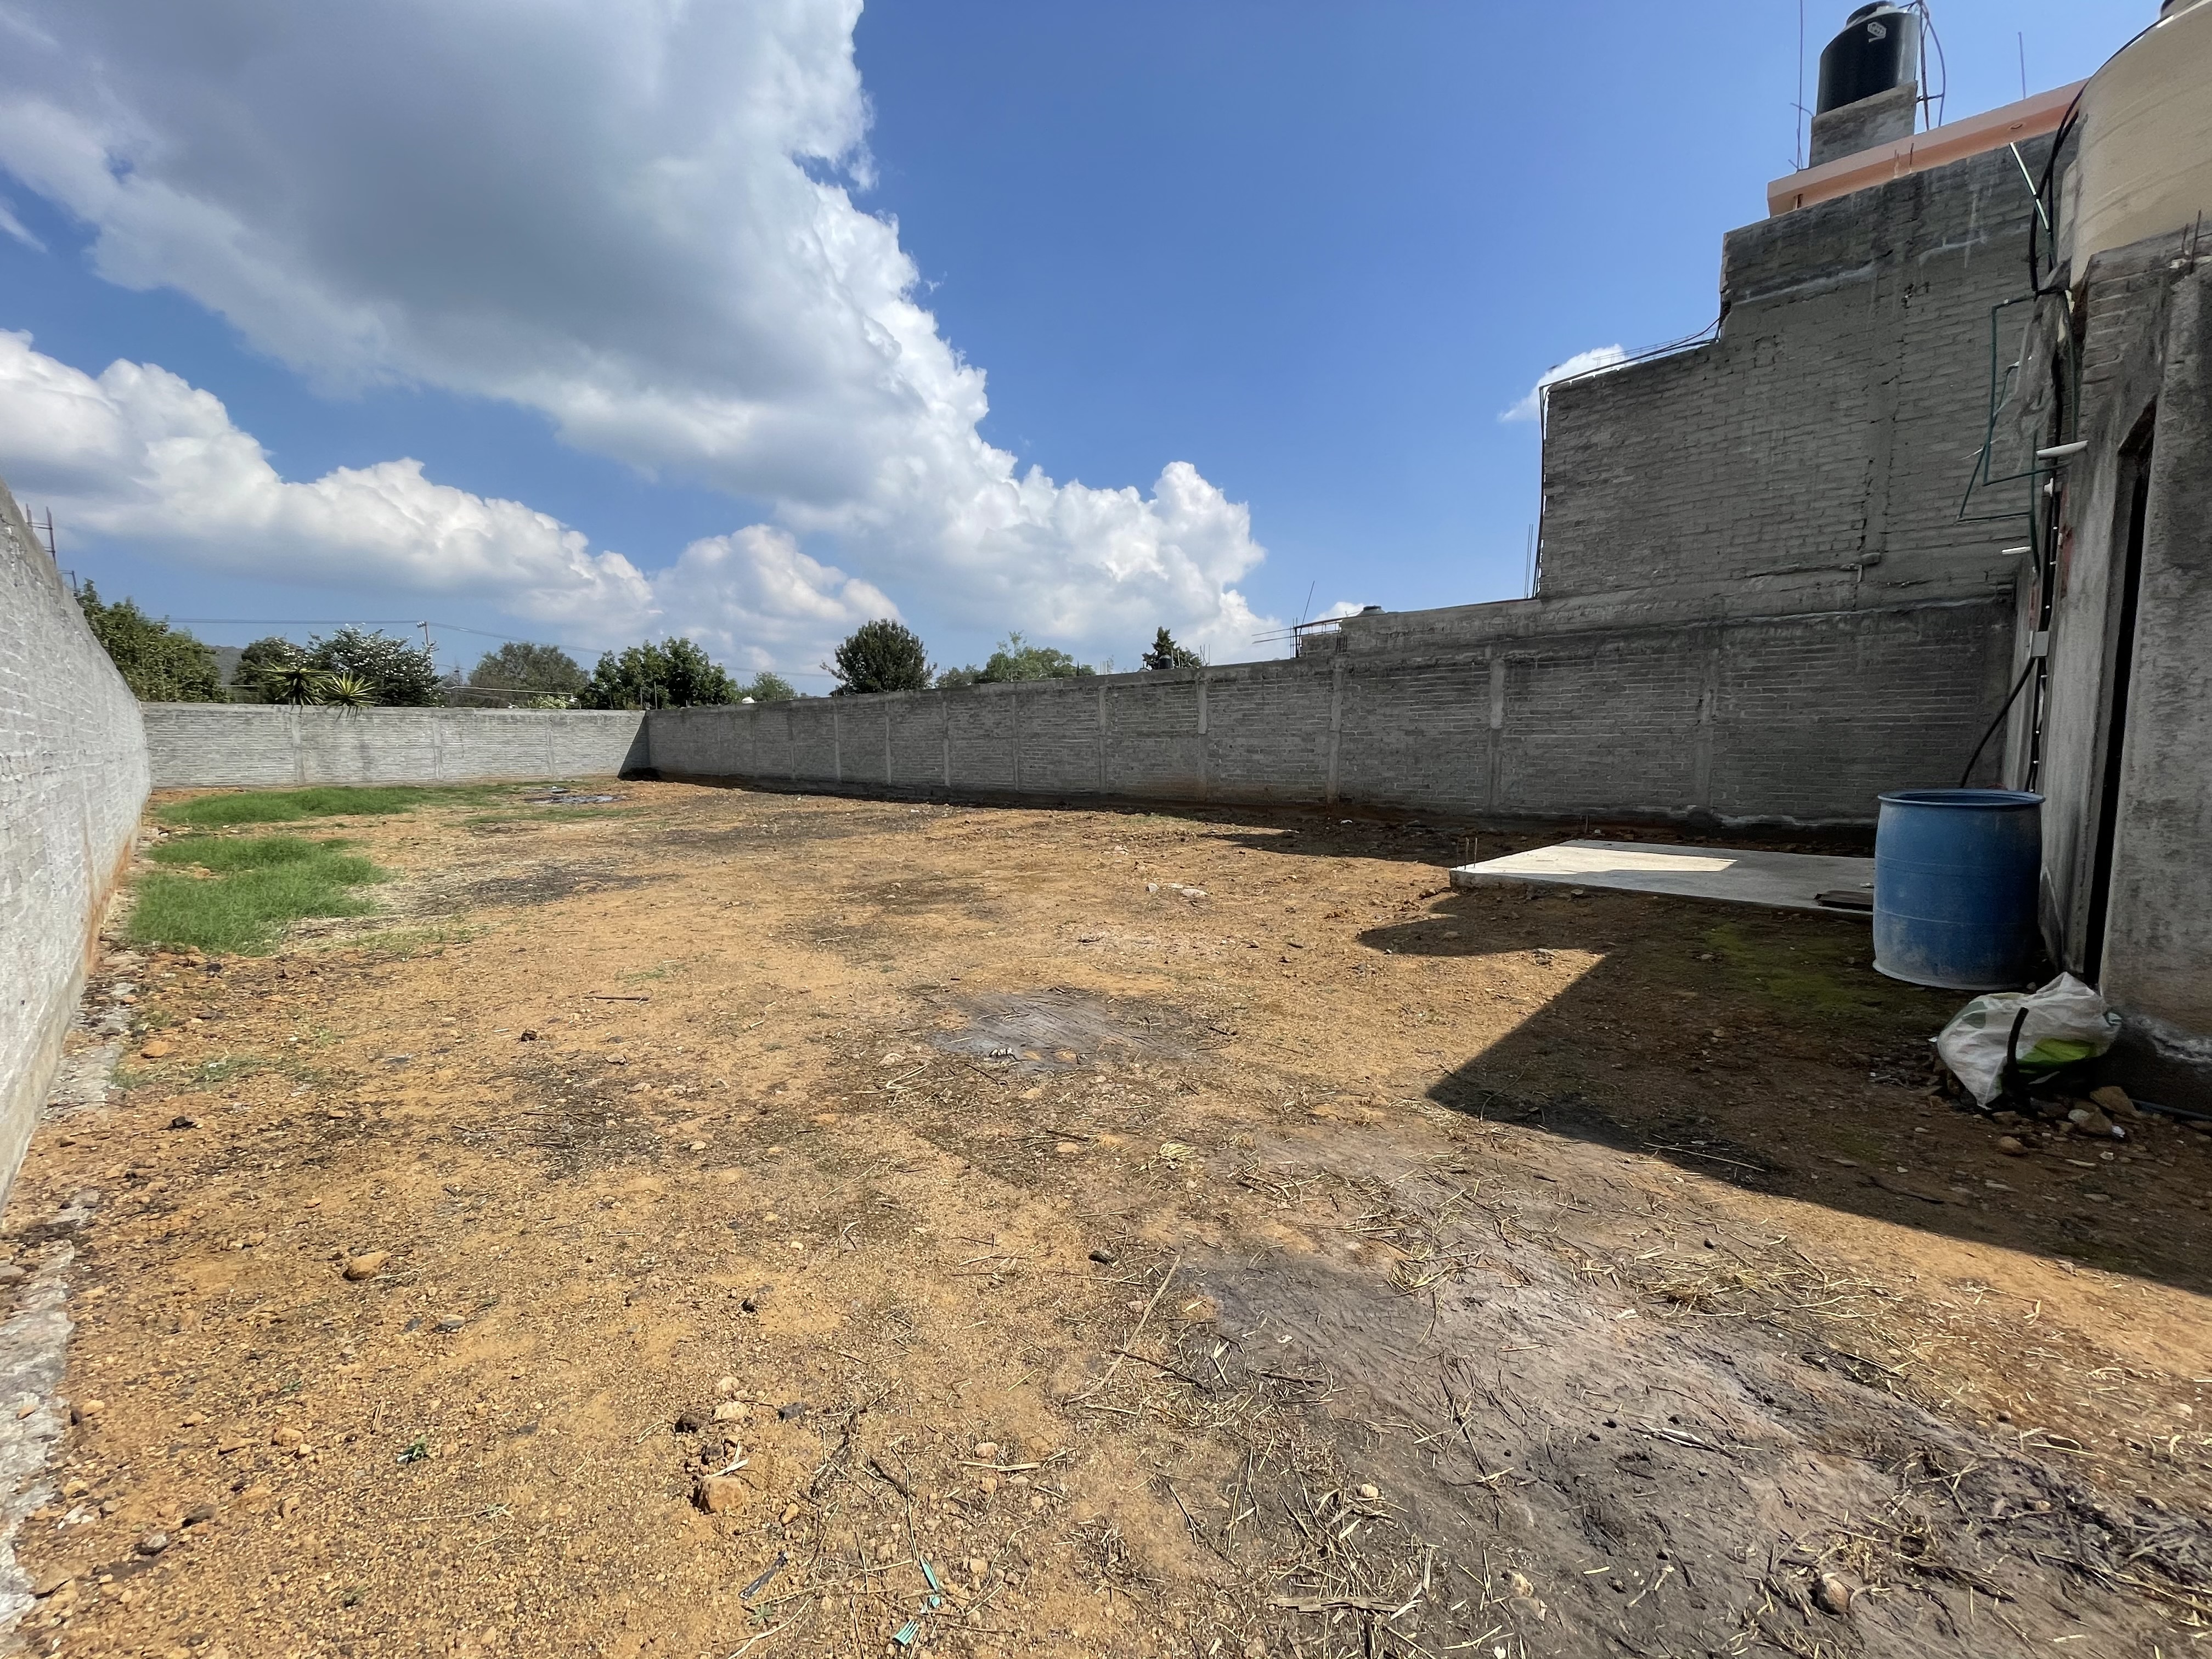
1874, 789, 2044, 991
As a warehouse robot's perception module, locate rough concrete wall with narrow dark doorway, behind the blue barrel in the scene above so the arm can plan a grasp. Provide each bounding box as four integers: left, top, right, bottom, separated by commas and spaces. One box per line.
2013, 236, 2212, 1106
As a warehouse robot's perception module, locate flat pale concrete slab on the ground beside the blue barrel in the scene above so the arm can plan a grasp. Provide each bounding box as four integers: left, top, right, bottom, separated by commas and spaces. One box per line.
1451, 840, 1874, 916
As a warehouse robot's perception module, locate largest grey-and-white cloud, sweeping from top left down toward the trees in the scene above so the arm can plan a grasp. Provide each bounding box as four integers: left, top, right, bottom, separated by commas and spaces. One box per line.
0, 0, 1263, 657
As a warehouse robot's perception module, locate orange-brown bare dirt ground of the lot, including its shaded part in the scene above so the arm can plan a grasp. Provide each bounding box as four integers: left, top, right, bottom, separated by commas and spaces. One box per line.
7, 783, 2212, 1659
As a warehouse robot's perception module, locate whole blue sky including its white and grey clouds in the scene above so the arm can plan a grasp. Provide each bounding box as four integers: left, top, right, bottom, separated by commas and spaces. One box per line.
0, 0, 2154, 688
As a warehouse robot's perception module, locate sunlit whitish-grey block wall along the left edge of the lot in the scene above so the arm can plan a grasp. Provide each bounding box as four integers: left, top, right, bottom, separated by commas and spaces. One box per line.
0, 484, 146, 1199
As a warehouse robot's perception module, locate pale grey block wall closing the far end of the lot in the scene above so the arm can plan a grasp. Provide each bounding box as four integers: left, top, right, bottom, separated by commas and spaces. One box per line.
144, 703, 646, 789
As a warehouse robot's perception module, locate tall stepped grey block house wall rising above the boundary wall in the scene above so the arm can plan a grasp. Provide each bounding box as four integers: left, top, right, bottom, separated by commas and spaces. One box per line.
1537, 139, 2049, 611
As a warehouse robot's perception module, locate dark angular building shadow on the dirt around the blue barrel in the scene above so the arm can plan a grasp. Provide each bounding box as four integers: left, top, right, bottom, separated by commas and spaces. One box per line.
1361, 889, 2212, 1294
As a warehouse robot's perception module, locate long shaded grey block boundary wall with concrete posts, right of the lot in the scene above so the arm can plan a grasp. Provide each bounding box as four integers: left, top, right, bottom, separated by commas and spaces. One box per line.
648, 597, 2011, 827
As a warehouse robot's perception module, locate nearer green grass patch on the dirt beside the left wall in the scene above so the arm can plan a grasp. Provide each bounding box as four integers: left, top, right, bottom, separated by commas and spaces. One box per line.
131, 836, 390, 956
